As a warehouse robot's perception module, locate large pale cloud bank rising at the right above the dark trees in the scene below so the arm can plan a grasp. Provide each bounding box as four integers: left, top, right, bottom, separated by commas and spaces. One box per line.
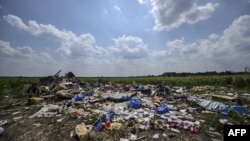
158, 15, 250, 71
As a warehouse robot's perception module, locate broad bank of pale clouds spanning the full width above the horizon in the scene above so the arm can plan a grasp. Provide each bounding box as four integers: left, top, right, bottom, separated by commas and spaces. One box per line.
0, 15, 250, 76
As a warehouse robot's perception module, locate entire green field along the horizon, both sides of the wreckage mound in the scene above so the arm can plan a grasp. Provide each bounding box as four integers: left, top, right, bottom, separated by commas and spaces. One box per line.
0, 74, 250, 94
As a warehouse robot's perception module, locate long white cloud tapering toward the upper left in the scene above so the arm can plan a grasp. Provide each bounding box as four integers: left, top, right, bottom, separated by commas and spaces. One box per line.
4, 15, 106, 57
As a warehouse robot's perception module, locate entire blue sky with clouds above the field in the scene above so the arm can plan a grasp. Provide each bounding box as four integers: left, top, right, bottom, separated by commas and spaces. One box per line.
0, 0, 250, 76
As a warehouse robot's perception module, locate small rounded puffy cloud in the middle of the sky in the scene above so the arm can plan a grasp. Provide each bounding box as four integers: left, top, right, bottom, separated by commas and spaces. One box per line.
109, 35, 148, 59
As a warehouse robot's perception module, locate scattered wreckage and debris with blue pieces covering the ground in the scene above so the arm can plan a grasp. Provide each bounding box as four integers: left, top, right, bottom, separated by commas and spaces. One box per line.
0, 71, 249, 141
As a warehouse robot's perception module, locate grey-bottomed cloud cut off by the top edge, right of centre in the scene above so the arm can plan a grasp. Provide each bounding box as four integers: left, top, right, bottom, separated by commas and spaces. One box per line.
151, 0, 218, 31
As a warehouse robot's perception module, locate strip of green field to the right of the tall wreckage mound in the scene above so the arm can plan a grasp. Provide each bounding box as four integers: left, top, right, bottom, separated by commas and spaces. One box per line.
79, 74, 250, 89
